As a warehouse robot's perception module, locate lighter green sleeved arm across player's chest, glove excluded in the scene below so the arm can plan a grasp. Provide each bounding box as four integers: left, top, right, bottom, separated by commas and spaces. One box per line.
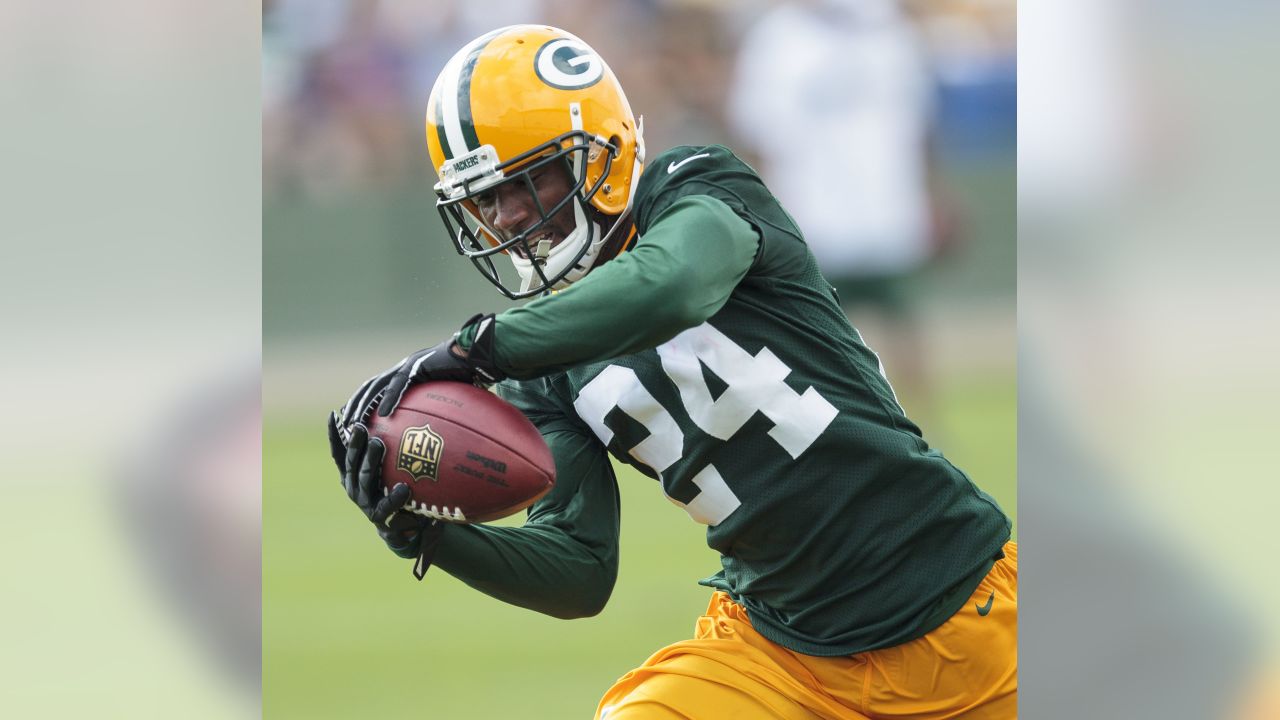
471, 195, 759, 378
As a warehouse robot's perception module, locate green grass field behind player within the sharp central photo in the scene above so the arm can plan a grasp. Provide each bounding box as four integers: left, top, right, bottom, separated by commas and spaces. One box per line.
262, 373, 1016, 719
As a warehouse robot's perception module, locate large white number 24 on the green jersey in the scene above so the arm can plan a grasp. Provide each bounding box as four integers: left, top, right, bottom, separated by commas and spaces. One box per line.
573, 323, 837, 527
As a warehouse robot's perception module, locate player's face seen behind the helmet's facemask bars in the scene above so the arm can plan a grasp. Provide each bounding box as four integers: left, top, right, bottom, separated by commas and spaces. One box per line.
475, 163, 575, 258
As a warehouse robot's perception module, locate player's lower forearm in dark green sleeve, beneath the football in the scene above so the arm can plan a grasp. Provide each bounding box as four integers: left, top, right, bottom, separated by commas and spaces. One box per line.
435, 525, 618, 619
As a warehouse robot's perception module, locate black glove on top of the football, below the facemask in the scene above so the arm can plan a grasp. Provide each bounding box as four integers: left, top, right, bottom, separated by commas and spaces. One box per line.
338, 315, 506, 429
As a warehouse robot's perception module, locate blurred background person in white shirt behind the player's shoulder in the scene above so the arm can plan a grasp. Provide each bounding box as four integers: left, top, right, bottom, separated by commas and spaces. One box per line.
730, 0, 955, 413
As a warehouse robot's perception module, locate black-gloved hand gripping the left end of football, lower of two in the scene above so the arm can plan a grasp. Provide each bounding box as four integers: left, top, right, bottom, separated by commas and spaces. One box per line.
329, 413, 438, 557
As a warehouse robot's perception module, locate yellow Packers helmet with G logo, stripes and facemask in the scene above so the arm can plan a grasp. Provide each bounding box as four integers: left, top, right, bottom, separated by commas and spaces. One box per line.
426, 26, 644, 299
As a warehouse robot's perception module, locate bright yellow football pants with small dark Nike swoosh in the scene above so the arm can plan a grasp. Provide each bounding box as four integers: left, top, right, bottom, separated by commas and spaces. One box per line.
595, 542, 1018, 720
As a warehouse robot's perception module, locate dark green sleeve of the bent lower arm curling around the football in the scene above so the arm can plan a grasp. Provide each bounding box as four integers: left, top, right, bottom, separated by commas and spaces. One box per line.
434, 383, 618, 619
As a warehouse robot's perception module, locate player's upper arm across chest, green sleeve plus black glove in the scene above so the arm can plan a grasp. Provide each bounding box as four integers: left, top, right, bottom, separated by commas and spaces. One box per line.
339, 195, 759, 420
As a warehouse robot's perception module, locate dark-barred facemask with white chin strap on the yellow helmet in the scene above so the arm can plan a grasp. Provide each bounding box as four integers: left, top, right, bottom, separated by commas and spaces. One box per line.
435, 129, 625, 300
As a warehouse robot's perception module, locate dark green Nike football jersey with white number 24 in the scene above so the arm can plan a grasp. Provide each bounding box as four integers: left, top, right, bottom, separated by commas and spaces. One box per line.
436, 146, 1010, 656
